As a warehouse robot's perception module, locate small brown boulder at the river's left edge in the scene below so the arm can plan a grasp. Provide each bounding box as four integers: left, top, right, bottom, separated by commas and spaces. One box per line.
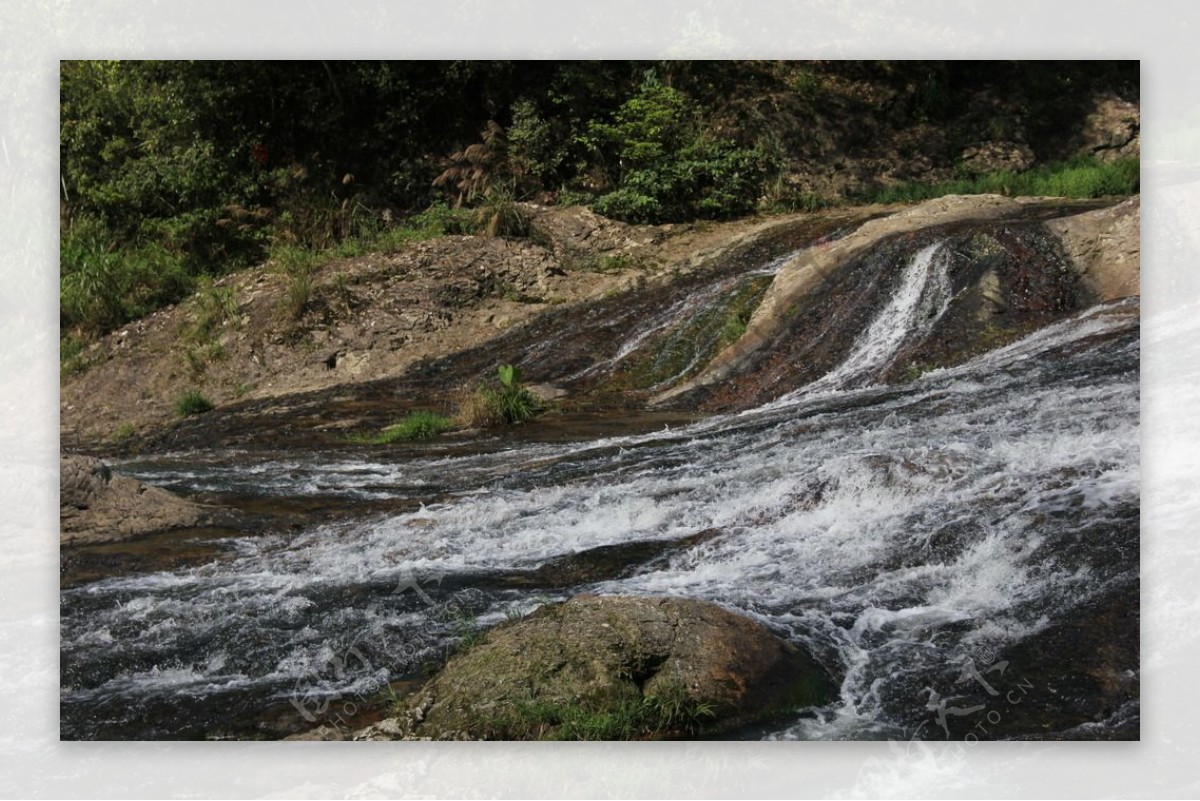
59, 454, 233, 544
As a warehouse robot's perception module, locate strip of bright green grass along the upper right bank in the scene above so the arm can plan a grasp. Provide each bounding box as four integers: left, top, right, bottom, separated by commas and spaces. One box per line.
854, 156, 1140, 203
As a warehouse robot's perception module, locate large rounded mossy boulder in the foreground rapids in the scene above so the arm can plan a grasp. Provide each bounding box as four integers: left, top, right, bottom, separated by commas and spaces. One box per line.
356, 596, 834, 740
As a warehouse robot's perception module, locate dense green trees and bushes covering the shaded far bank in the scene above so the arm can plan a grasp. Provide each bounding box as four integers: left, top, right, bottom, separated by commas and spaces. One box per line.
60, 61, 1139, 347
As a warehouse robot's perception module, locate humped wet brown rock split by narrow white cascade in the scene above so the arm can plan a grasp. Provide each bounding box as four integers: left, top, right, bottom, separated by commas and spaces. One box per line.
652, 195, 1138, 411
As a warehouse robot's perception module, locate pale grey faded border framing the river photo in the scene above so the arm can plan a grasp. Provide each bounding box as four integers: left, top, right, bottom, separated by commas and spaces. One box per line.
0, 0, 1200, 799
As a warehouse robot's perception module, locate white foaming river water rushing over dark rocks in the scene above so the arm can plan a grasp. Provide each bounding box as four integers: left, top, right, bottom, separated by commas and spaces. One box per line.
61, 236, 1139, 739
